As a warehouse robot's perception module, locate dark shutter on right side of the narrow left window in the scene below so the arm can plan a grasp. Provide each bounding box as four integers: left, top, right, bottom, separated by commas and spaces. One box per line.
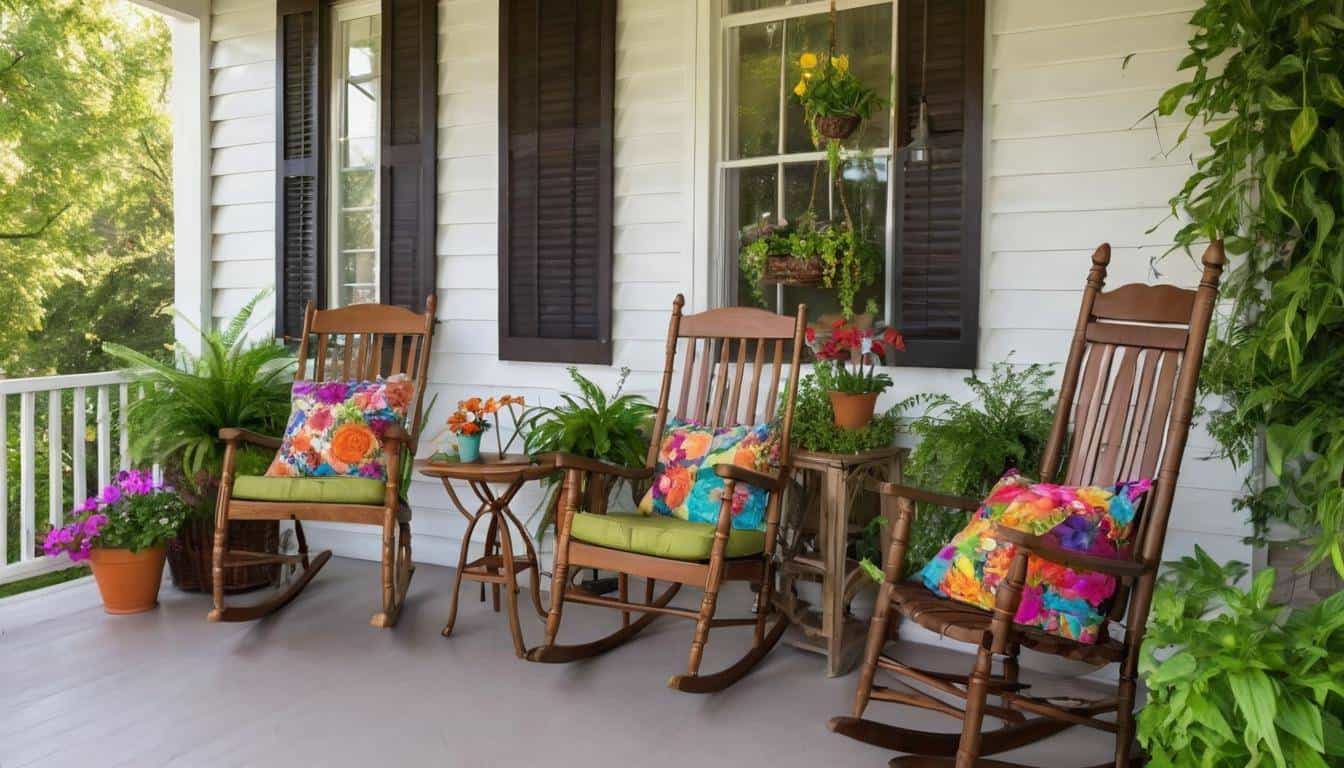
379, 0, 438, 312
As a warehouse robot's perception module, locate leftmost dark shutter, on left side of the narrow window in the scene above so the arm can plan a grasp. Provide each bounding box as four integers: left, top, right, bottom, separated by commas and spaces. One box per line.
276, 0, 325, 338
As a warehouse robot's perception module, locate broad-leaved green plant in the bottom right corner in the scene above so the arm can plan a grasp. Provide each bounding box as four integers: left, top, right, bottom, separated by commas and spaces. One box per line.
1138, 546, 1344, 768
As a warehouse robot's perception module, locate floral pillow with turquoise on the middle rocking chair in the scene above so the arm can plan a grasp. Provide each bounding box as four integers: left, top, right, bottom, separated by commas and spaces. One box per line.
640, 418, 780, 530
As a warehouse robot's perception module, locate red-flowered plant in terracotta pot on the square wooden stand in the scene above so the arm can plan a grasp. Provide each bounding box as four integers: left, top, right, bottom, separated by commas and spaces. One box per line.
808, 320, 906, 429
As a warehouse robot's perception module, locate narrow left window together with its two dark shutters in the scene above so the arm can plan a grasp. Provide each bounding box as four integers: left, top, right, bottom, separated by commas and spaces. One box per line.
276, 0, 438, 338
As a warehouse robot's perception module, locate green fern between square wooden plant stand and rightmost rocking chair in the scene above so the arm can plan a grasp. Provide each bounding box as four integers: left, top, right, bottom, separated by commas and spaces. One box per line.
896, 360, 1055, 573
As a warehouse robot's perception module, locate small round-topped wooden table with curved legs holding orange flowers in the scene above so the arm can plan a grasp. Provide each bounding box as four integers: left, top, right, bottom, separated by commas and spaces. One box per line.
418, 453, 555, 658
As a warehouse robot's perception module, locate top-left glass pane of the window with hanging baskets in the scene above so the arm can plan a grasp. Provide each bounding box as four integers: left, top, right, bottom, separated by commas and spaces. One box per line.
727, 22, 784, 159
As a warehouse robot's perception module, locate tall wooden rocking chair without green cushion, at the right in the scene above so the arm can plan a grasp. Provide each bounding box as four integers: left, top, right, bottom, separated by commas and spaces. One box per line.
829, 241, 1224, 768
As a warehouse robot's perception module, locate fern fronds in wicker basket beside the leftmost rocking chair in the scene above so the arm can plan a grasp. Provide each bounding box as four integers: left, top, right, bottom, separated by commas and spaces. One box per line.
103, 295, 294, 489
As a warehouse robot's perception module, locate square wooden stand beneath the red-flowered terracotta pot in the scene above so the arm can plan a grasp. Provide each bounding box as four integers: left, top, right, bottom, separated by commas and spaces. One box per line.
774, 448, 909, 677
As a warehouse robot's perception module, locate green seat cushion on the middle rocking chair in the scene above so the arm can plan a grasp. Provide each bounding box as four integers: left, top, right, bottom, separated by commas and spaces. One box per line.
570, 512, 765, 560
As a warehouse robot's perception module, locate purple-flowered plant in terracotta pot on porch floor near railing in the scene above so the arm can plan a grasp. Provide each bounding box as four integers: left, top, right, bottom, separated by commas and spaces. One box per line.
42, 469, 191, 613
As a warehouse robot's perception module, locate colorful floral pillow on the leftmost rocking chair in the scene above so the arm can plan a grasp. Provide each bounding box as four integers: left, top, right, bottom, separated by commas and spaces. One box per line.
266, 375, 415, 480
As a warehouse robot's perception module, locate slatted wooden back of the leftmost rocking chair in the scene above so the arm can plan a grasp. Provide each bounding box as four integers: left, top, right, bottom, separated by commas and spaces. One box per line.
294, 295, 437, 453
